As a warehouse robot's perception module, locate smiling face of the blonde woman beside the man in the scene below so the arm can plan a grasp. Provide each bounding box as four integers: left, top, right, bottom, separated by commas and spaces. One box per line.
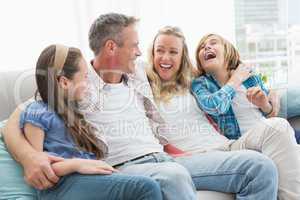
153, 35, 183, 81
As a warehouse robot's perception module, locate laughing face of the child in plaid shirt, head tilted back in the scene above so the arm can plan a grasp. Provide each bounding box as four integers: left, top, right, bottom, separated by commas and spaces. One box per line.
198, 35, 227, 74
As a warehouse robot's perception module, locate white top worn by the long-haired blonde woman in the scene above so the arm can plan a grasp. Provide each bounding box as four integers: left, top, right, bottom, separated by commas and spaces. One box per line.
159, 92, 229, 152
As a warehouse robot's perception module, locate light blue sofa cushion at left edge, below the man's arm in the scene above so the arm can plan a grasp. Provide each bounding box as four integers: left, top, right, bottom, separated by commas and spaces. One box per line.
0, 122, 37, 200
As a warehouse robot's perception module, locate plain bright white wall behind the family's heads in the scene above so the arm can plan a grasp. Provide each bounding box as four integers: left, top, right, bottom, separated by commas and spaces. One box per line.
0, 0, 234, 70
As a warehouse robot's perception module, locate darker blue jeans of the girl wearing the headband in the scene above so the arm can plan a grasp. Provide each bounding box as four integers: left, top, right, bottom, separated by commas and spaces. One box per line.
38, 173, 162, 200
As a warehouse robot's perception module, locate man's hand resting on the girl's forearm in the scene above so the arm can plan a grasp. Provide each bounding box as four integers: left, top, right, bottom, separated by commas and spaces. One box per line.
22, 152, 63, 190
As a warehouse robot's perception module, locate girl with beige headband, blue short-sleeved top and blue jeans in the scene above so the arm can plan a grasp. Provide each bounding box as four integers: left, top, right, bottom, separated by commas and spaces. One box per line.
20, 45, 162, 200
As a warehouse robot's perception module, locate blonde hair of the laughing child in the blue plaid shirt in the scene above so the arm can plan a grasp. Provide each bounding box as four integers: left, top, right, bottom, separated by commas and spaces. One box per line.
196, 33, 241, 75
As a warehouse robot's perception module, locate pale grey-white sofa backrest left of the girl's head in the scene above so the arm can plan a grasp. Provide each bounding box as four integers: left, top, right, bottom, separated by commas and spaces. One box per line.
0, 69, 36, 121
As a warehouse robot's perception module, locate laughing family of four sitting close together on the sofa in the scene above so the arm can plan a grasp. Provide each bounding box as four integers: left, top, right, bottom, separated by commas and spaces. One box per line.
4, 13, 300, 200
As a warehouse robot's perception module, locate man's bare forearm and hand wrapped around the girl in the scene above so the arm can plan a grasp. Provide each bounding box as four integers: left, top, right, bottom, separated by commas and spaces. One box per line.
3, 108, 62, 189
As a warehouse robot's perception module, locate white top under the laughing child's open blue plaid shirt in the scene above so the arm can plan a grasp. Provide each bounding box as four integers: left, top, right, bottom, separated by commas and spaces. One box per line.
232, 85, 265, 135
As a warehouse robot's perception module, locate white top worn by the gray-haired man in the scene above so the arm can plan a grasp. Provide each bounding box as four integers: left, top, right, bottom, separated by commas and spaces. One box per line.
81, 65, 163, 165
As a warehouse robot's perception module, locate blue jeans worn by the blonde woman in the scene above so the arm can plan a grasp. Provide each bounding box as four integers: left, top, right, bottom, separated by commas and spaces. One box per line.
175, 150, 278, 200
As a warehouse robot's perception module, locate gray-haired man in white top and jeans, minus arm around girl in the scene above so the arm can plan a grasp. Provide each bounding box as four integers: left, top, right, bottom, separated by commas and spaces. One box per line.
80, 13, 196, 200
